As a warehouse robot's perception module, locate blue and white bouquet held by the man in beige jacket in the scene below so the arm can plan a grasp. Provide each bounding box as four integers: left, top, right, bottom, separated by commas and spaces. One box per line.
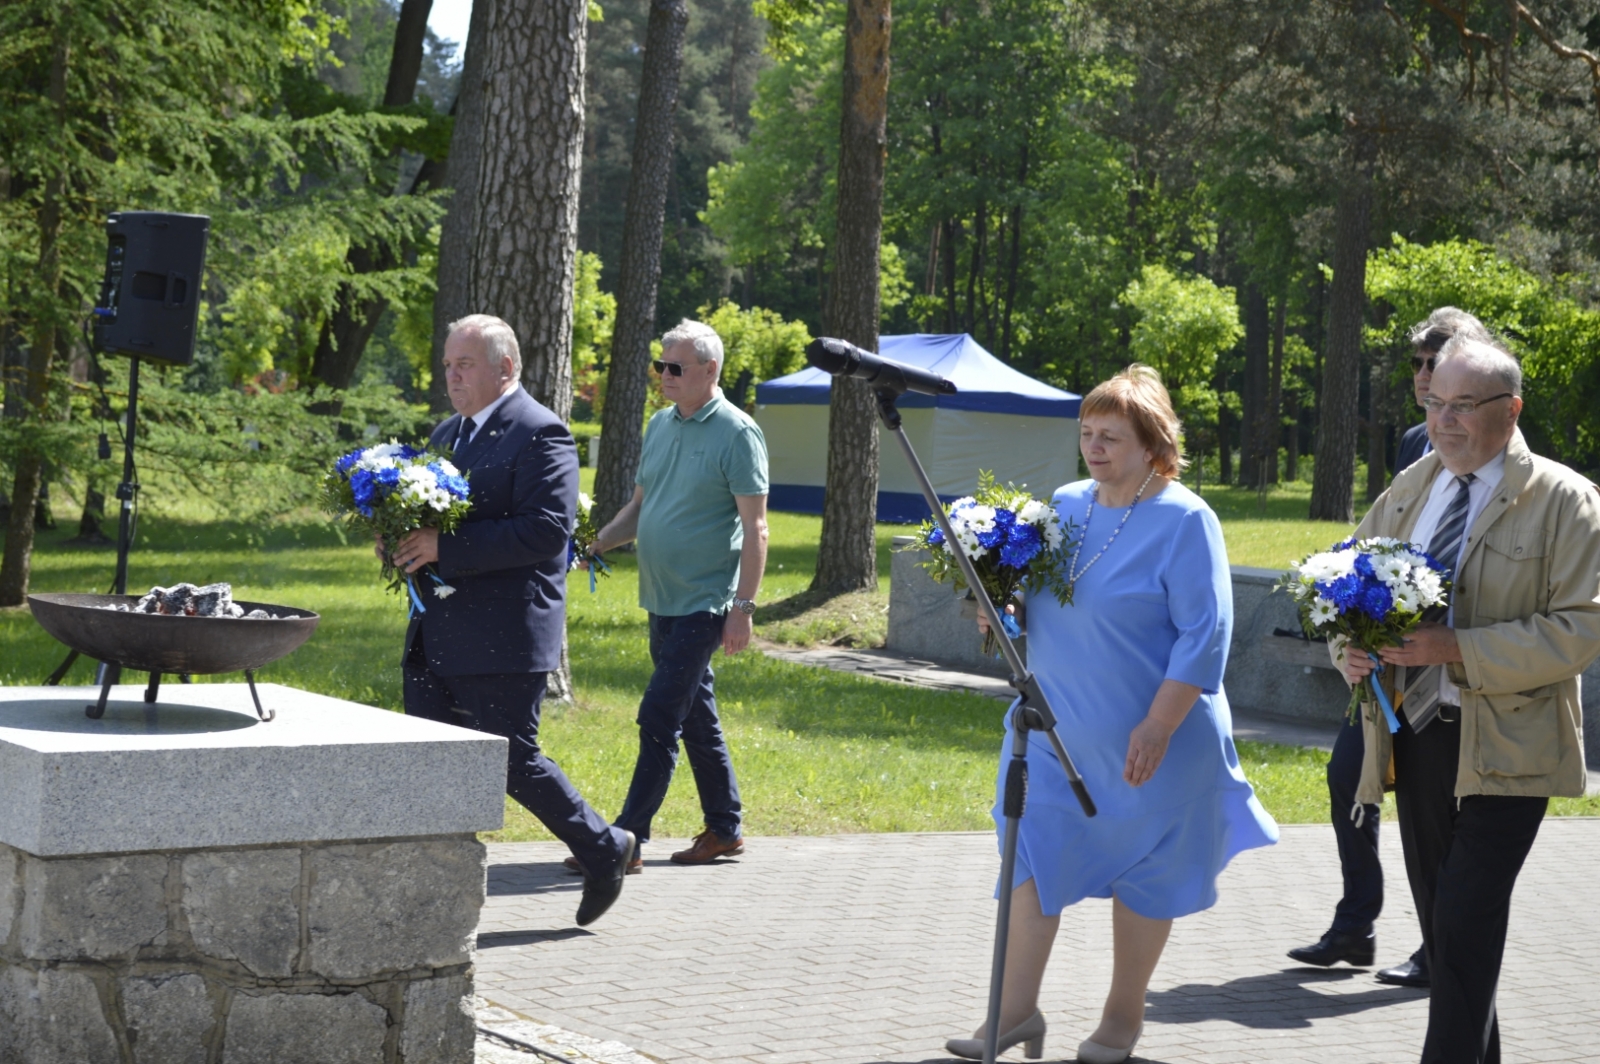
1278, 536, 1450, 731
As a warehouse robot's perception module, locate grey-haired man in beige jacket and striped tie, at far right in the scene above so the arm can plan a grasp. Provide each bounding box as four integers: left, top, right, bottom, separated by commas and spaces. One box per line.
1334, 341, 1600, 1064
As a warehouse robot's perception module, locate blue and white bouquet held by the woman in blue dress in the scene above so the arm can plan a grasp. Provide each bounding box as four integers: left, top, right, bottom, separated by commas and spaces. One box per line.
902, 472, 1077, 654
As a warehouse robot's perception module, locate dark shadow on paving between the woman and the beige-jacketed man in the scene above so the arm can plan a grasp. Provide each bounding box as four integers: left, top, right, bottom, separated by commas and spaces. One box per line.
1147, 968, 1427, 1030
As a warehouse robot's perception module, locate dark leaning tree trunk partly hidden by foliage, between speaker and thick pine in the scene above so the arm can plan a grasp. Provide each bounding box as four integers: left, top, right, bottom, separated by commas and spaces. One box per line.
310, 0, 434, 400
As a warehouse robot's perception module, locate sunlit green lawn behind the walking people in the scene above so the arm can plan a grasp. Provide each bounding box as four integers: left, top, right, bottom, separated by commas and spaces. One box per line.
0, 470, 1600, 840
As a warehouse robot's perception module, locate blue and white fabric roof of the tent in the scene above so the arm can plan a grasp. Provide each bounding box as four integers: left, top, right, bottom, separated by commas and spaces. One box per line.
755, 333, 1083, 418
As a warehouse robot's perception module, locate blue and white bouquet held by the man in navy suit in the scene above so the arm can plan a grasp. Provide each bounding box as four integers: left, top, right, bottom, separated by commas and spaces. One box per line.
322, 440, 472, 614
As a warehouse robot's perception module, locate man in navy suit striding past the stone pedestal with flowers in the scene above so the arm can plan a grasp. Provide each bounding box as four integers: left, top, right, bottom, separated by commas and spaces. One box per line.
394, 314, 637, 925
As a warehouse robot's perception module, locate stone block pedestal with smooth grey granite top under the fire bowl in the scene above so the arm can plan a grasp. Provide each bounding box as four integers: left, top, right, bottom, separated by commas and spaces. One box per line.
0, 683, 506, 1064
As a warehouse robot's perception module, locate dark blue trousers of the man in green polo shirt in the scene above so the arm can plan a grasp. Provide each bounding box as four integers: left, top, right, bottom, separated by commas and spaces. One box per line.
616, 611, 744, 845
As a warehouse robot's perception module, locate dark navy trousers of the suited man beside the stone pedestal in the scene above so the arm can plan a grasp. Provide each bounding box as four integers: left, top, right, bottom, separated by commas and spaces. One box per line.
405, 637, 624, 875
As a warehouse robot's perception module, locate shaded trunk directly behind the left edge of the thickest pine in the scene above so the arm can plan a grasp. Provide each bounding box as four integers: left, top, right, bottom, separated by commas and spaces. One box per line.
427, 0, 494, 413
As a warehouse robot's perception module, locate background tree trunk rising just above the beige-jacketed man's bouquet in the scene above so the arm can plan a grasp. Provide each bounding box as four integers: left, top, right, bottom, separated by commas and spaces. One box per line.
1310, 160, 1373, 522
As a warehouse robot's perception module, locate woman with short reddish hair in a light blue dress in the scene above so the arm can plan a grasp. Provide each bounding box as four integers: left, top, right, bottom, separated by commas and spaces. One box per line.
946, 365, 1278, 1064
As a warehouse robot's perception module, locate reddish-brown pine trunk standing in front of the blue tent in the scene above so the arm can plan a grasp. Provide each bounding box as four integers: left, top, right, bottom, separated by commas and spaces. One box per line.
811, 0, 891, 595
